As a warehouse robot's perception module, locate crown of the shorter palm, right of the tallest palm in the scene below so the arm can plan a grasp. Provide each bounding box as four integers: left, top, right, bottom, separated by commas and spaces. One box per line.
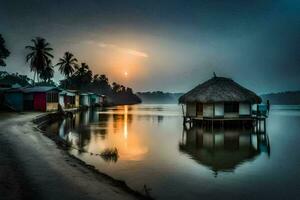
56, 52, 77, 79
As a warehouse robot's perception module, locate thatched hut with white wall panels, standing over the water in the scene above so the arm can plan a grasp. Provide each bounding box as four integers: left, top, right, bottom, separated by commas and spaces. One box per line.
179, 76, 261, 120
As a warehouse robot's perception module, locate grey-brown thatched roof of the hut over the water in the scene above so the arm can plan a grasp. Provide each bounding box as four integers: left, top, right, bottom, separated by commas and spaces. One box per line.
179, 77, 261, 103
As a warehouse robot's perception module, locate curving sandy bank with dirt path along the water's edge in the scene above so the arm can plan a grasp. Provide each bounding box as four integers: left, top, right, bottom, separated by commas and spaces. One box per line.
0, 113, 149, 200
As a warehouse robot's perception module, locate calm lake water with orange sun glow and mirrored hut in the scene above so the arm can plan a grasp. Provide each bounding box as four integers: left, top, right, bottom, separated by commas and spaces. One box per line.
47, 105, 300, 200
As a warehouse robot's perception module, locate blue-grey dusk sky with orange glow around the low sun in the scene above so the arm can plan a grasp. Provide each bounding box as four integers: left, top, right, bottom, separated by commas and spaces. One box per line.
0, 0, 300, 93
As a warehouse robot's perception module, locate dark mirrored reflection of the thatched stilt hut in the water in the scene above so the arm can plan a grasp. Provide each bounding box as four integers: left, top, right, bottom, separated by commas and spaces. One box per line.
179, 127, 270, 175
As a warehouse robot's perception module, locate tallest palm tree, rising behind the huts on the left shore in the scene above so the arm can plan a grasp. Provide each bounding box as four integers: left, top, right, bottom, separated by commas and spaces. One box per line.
25, 37, 53, 82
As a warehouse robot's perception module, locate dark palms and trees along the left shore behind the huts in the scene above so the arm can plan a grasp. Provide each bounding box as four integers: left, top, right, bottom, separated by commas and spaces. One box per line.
0, 34, 141, 104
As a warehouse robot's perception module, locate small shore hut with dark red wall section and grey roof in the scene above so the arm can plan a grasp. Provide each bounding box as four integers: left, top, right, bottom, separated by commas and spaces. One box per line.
22, 86, 60, 112
